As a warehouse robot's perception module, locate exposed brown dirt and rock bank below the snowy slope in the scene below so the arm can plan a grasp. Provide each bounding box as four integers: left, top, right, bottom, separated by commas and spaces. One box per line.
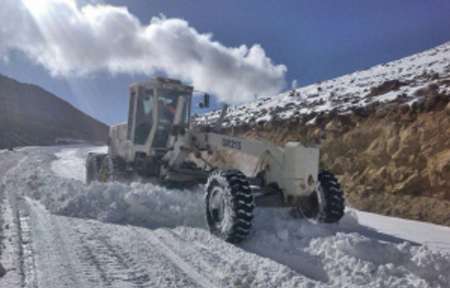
220, 93, 450, 226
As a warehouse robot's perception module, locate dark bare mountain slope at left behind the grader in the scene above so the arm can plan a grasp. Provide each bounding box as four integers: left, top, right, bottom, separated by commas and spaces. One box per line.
0, 75, 108, 149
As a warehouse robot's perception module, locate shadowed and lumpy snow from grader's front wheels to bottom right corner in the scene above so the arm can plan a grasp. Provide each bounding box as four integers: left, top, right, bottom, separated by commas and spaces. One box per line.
242, 209, 450, 287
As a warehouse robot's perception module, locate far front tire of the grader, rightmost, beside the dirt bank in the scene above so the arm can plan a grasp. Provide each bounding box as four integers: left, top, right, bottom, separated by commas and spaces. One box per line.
317, 170, 345, 223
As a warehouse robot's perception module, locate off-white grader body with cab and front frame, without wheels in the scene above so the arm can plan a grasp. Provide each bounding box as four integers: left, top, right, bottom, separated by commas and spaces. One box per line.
109, 78, 319, 203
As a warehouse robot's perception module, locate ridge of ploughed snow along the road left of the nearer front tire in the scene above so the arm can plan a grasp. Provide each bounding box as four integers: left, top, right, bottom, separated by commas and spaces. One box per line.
3, 149, 205, 228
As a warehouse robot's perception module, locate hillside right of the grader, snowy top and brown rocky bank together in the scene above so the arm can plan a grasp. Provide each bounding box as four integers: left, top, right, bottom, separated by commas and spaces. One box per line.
198, 42, 450, 226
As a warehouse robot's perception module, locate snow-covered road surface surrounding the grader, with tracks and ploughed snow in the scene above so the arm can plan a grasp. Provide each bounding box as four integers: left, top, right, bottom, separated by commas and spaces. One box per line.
0, 147, 450, 288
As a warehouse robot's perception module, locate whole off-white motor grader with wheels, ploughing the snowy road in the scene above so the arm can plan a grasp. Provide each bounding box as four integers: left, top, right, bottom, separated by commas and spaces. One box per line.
86, 78, 344, 243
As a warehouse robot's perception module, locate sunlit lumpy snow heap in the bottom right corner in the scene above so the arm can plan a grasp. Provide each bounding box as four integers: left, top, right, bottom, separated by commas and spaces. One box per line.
307, 233, 450, 287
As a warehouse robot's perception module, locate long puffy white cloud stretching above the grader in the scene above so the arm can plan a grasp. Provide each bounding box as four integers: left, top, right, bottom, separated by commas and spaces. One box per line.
0, 0, 287, 103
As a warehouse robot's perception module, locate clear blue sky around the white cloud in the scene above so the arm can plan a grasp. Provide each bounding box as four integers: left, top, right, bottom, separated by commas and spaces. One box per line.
0, 0, 450, 124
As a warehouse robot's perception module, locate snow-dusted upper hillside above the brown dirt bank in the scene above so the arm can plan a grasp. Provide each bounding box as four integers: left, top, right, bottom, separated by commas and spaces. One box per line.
197, 42, 450, 127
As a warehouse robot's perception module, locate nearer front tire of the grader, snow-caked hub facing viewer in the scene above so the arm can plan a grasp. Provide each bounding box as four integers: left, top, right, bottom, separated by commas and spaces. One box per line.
205, 170, 255, 243
